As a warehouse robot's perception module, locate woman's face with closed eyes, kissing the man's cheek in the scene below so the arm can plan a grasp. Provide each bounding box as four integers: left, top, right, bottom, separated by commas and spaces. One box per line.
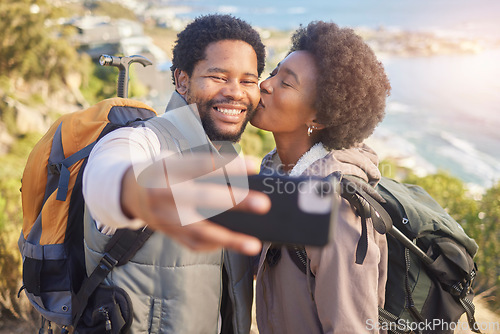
251, 51, 317, 134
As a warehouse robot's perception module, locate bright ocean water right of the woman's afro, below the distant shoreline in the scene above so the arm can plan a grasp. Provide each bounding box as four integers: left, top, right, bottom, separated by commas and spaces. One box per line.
373, 49, 500, 187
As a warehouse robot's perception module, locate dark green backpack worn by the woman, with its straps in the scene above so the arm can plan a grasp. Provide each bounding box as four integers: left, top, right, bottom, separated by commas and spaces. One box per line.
288, 176, 480, 334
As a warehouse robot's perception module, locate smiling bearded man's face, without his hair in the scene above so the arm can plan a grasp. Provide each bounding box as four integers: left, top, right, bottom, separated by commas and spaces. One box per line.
177, 40, 260, 142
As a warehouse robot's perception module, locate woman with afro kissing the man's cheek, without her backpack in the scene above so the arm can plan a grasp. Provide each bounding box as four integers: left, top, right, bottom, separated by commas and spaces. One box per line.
252, 22, 390, 334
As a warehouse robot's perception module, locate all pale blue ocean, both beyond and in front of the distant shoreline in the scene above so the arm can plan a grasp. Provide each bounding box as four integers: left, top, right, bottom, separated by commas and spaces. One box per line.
164, 0, 500, 188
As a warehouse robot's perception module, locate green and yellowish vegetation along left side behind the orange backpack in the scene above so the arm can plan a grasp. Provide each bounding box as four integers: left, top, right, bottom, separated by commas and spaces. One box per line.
0, 0, 145, 320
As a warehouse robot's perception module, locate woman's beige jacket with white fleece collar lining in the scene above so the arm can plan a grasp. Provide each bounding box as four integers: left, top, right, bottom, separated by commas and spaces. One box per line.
256, 144, 387, 334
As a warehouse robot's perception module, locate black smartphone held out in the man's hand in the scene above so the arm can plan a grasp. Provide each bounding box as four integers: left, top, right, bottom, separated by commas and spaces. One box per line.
198, 175, 340, 246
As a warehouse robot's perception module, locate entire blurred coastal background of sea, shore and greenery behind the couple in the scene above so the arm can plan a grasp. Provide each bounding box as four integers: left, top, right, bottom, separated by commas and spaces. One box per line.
0, 0, 500, 333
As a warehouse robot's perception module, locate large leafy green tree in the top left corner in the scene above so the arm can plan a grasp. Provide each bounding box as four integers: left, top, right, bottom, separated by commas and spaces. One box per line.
0, 0, 84, 87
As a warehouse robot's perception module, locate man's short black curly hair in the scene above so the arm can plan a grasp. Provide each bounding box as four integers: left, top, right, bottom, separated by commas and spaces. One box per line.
170, 14, 265, 84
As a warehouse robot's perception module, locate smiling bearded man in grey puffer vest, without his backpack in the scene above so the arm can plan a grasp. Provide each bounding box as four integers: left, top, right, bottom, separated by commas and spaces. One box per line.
83, 15, 270, 334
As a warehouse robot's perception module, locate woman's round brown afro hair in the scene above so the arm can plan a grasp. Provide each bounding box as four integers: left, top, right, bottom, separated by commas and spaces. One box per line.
290, 21, 391, 149
